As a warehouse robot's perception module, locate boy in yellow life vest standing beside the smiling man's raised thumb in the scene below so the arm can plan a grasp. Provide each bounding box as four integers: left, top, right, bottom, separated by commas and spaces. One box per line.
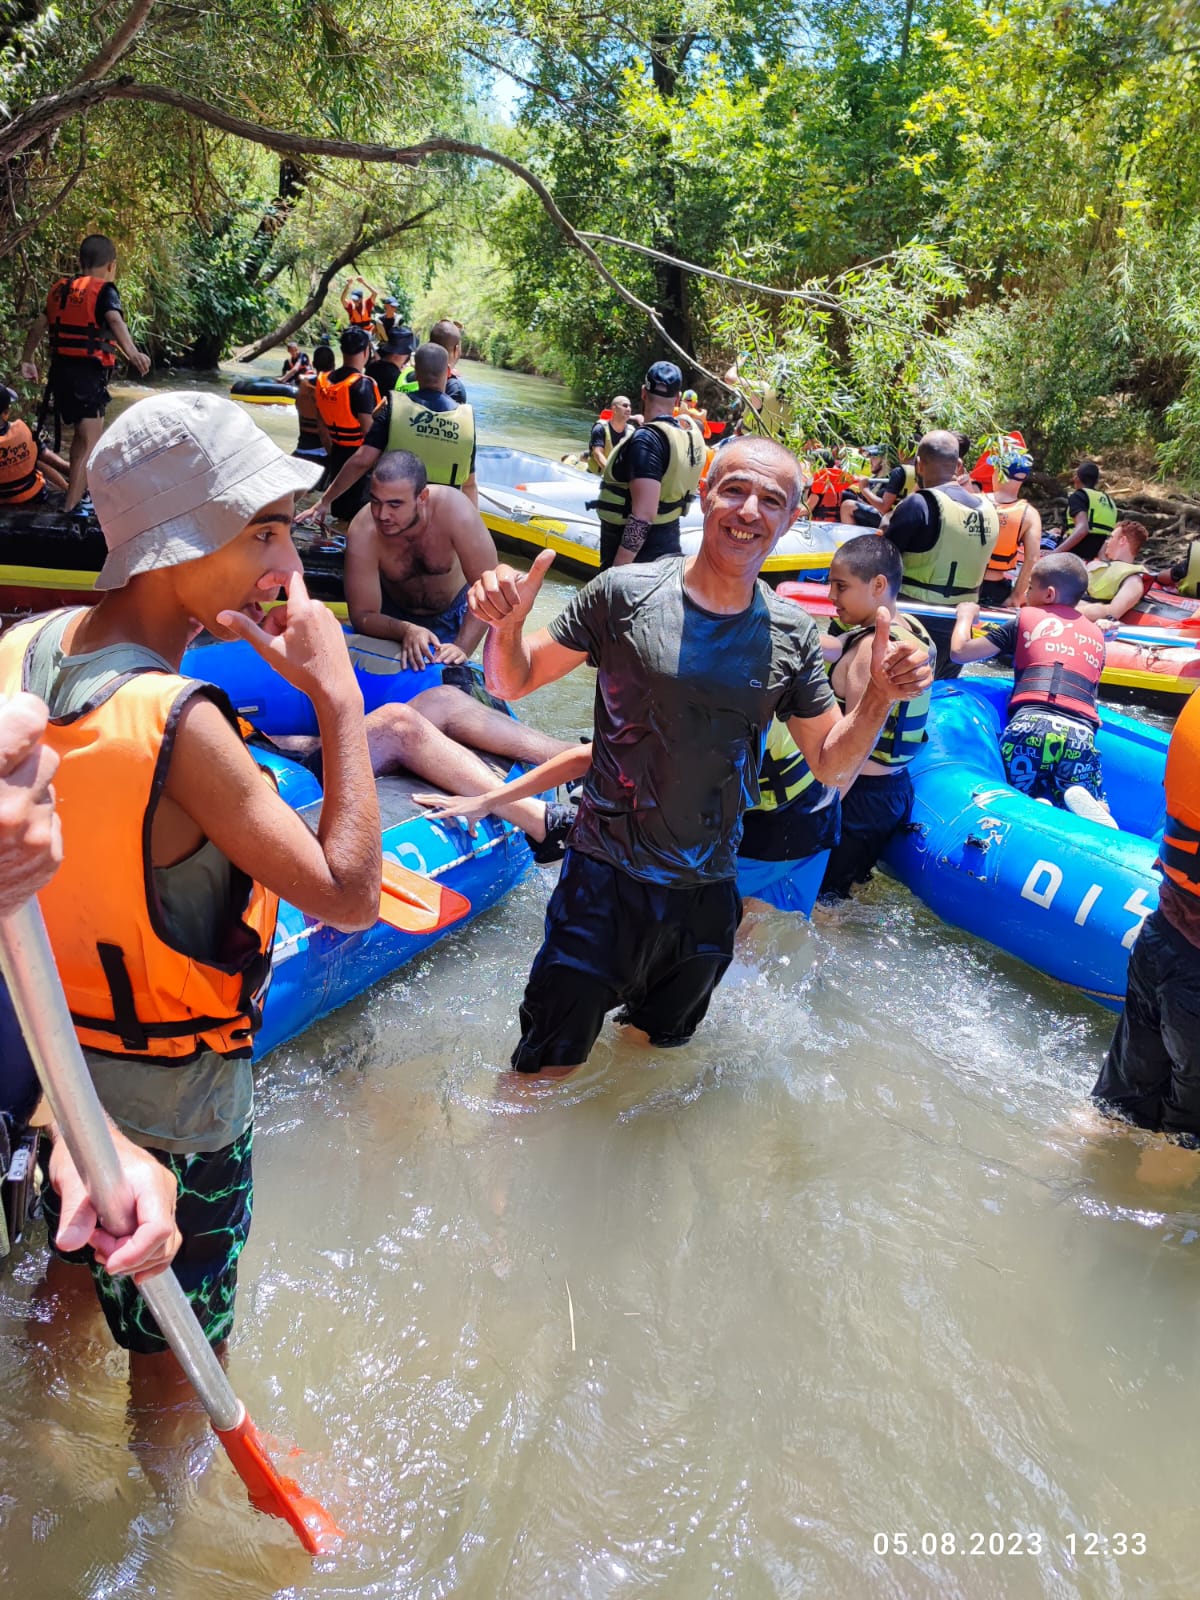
821, 533, 936, 902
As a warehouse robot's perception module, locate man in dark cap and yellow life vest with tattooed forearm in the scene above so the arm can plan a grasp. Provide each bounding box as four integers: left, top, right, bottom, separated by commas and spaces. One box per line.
589, 362, 704, 571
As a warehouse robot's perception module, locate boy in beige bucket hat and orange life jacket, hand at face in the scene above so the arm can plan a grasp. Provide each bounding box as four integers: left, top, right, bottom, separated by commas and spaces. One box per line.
0, 392, 381, 1392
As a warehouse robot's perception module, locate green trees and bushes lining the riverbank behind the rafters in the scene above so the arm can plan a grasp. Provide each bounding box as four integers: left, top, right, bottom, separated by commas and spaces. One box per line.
0, 0, 1200, 485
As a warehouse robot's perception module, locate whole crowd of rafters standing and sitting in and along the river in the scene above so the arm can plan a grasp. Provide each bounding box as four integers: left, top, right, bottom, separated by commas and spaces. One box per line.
0, 238, 1200, 1465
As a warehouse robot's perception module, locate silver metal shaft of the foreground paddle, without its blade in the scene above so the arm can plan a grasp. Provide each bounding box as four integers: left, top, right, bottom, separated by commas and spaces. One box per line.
0, 899, 243, 1429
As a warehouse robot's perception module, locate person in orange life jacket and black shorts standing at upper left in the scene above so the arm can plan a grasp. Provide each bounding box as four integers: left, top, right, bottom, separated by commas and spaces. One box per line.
21, 234, 150, 512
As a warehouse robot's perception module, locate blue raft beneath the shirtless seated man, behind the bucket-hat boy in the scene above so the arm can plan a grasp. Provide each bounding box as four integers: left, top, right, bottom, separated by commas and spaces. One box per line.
182, 635, 531, 1056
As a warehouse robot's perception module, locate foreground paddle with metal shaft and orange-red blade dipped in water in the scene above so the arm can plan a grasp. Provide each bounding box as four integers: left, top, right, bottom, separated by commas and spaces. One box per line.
0, 899, 341, 1555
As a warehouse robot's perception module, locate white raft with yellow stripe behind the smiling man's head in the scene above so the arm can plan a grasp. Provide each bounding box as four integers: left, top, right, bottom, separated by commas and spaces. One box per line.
475, 445, 862, 582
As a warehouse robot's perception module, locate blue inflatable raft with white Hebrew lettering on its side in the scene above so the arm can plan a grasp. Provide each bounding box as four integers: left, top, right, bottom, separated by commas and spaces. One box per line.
883, 677, 1170, 1010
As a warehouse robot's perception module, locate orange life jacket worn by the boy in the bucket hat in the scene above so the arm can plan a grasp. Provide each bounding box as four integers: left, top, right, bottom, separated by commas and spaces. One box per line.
0, 613, 278, 1067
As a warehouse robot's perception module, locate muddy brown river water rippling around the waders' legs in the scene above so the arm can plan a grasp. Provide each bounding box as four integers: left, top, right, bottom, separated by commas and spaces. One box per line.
0, 363, 1200, 1600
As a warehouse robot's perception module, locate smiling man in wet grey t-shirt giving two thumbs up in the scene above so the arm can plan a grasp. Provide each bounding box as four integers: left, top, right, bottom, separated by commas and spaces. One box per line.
470, 440, 931, 1072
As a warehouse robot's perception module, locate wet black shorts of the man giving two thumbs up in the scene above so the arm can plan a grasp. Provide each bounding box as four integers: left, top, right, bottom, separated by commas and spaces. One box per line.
512, 850, 742, 1072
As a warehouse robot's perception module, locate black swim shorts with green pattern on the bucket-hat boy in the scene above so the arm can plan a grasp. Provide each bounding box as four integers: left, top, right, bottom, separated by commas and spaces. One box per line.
43, 1128, 254, 1355
